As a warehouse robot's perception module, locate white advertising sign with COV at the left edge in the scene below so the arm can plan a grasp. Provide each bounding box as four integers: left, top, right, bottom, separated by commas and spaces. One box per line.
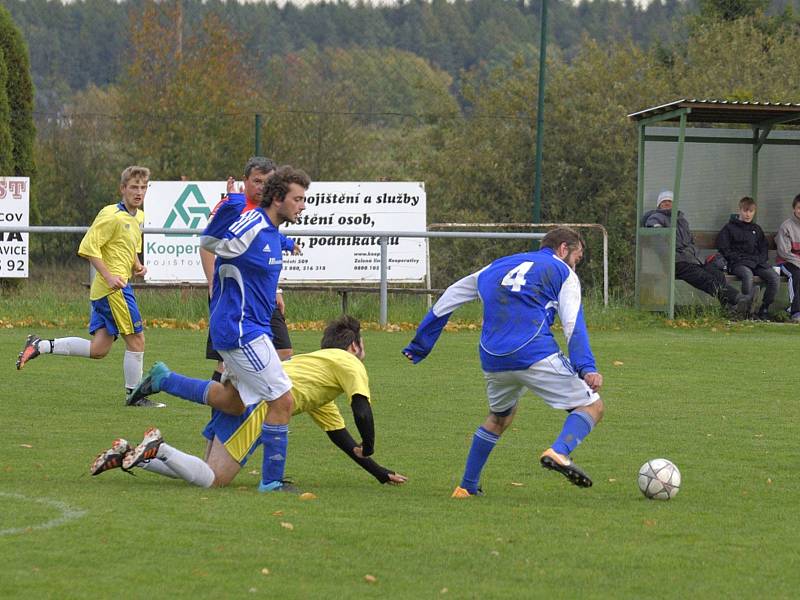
0, 177, 31, 278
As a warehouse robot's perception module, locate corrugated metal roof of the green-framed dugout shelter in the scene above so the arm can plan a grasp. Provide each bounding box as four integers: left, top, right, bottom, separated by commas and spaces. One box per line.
628, 98, 800, 125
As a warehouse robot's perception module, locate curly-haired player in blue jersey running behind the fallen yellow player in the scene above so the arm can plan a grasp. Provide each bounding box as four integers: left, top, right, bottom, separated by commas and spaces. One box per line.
131, 166, 310, 491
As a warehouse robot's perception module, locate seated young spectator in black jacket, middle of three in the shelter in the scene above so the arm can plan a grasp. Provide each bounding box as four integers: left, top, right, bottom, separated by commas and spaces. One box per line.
717, 196, 780, 320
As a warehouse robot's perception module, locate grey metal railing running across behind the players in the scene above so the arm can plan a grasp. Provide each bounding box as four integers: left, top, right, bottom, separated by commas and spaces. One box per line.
0, 223, 608, 327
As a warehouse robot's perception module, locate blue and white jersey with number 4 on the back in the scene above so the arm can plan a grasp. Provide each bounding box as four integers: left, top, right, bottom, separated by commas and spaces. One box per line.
405, 248, 597, 377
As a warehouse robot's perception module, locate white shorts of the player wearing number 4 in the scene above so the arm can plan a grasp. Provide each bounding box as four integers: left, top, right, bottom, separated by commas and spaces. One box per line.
483, 352, 600, 413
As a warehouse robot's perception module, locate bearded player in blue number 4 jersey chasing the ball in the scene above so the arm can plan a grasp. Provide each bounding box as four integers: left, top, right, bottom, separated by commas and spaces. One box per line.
403, 227, 604, 498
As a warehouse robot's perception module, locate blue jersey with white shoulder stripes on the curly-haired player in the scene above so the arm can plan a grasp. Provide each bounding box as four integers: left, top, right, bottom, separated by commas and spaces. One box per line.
200, 199, 283, 350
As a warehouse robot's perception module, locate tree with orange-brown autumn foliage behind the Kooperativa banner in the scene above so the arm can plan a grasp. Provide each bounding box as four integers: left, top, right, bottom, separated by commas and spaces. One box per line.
120, 1, 250, 179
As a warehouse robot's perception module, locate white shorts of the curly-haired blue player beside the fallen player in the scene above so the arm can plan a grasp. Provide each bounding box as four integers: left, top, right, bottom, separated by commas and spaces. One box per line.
219, 335, 292, 406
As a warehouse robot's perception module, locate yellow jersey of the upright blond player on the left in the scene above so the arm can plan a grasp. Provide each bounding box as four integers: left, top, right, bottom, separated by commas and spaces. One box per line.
78, 202, 144, 300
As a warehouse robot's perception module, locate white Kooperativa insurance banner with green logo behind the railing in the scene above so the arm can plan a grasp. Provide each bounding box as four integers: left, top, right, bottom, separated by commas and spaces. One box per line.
144, 181, 428, 283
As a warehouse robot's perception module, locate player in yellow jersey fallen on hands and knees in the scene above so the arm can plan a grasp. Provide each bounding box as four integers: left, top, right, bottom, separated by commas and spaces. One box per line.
90, 316, 406, 487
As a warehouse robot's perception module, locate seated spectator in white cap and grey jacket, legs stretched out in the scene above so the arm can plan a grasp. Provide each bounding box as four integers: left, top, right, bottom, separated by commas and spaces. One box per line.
642, 190, 755, 316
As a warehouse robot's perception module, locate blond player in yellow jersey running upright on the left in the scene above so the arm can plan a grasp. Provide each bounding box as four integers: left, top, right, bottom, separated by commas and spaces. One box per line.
17, 166, 164, 407
